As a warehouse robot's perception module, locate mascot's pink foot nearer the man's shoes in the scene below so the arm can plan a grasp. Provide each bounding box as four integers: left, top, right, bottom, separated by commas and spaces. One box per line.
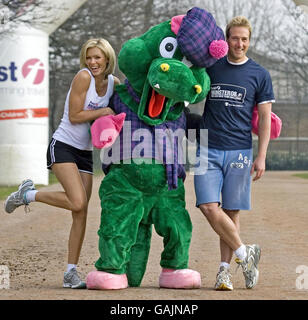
159, 269, 201, 289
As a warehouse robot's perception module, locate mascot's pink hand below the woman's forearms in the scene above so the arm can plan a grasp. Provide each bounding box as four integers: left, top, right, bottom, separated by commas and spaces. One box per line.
91, 112, 126, 149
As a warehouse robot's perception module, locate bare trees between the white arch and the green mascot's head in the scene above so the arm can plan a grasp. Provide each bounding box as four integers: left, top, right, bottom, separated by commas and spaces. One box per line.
50, 0, 192, 131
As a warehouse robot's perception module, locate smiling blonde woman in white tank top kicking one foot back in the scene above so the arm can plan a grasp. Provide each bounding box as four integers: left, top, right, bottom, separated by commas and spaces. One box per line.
5, 39, 120, 289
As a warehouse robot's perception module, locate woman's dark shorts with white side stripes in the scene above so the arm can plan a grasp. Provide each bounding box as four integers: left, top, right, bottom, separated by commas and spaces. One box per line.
47, 138, 93, 174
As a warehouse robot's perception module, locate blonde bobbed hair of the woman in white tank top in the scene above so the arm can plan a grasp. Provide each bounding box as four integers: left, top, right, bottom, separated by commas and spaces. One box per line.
80, 38, 116, 75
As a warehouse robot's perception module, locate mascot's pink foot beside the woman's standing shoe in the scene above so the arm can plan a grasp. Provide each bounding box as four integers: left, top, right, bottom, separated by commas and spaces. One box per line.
86, 271, 128, 290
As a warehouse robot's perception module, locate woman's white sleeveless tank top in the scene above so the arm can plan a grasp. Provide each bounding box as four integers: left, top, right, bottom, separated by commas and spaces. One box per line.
52, 68, 114, 150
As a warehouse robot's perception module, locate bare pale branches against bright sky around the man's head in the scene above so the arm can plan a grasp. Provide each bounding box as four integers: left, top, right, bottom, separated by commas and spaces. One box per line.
197, 0, 308, 103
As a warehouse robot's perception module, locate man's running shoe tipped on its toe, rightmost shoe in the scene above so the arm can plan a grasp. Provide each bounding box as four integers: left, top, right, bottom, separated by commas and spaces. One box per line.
235, 244, 261, 289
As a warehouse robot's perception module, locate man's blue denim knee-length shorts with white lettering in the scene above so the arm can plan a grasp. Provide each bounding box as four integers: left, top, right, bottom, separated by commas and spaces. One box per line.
194, 146, 253, 210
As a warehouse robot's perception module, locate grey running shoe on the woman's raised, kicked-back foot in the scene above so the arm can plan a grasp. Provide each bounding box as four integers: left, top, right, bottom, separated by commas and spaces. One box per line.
4, 179, 35, 213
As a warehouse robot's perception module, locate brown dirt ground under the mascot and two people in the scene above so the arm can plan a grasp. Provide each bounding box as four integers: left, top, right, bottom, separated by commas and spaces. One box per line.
0, 172, 308, 300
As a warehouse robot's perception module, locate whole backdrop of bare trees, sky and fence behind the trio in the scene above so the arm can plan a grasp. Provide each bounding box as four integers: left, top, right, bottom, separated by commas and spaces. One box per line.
49, 0, 308, 170
